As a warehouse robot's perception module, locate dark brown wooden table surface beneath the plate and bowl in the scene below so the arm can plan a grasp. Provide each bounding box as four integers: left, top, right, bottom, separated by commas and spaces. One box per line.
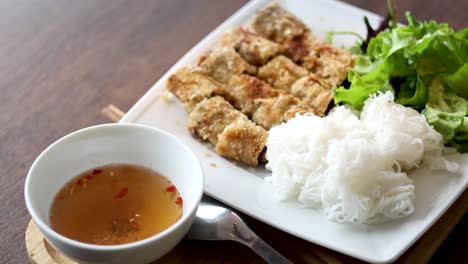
0, 0, 468, 263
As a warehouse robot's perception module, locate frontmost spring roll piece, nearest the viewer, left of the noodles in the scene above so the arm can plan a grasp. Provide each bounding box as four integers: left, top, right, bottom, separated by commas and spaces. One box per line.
215, 119, 268, 166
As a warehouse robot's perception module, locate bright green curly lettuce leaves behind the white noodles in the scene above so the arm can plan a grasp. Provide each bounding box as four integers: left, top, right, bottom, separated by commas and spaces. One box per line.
334, 13, 468, 152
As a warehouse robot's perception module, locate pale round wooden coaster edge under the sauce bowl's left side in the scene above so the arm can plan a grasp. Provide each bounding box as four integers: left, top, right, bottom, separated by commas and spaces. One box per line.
25, 220, 76, 264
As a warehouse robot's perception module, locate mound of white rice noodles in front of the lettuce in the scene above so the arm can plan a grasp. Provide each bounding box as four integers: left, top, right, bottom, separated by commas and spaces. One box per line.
266, 92, 458, 223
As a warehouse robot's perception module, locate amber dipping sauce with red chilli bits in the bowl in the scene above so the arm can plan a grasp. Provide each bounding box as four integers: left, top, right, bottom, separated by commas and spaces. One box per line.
50, 164, 183, 245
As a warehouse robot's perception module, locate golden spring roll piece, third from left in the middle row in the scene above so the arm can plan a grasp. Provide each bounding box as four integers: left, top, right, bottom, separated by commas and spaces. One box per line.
257, 55, 309, 92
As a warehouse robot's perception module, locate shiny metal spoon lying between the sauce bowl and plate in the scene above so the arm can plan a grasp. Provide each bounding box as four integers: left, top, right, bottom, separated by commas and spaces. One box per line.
186, 197, 291, 264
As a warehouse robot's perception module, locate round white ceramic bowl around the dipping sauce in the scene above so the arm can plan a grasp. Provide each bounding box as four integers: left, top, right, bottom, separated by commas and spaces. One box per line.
25, 124, 203, 263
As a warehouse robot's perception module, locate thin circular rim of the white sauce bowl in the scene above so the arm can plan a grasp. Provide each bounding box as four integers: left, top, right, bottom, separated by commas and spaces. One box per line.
24, 123, 204, 252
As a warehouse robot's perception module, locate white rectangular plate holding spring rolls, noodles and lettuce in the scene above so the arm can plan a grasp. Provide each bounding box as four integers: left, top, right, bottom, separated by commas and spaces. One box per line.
122, 0, 468, 263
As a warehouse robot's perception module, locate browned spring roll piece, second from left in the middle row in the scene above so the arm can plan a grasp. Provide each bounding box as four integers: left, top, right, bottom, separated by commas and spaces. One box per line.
223, 74, 281, 116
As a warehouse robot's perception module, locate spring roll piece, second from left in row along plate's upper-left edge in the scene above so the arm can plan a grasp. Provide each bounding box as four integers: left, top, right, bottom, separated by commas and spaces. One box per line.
200, 47, 257, 83
